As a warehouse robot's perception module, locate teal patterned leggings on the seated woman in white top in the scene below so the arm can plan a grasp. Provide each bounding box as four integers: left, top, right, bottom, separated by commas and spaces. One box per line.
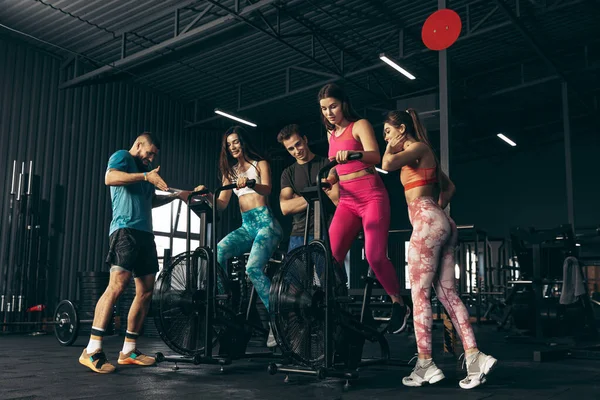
217, 206, 283, 310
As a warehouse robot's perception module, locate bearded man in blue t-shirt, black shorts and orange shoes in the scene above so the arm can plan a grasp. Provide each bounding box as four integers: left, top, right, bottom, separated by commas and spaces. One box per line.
79, 132, 190, 373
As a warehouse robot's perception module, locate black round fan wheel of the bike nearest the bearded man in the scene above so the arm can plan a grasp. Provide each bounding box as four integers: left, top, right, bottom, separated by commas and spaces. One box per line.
152, 248, 229, 356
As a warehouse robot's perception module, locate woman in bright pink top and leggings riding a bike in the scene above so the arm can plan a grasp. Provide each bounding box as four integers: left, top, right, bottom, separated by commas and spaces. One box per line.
318, 84, 410, 333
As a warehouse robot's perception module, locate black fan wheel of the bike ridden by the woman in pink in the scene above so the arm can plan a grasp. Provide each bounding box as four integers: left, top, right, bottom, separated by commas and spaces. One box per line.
269, 242, 344, 367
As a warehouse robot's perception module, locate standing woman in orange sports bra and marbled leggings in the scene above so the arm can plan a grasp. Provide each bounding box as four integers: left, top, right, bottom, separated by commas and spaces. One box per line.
382, 109, 497, 389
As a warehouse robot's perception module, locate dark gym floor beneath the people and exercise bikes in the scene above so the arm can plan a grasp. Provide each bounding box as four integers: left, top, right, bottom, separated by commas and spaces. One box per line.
0, 326, 600, 400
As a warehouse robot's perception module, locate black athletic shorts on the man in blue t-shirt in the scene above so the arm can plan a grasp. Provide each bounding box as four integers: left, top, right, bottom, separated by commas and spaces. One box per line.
106, 228, 158, 277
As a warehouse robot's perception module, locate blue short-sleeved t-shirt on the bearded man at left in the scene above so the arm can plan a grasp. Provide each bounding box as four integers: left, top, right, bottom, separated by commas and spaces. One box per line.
106, 150, 154, 235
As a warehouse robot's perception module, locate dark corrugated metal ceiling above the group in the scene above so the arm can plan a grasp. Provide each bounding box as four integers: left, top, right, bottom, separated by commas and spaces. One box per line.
0, 0, 599, 142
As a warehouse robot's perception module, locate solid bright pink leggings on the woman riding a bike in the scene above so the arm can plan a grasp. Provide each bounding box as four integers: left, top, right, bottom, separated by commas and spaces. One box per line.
329, 174, 400, 296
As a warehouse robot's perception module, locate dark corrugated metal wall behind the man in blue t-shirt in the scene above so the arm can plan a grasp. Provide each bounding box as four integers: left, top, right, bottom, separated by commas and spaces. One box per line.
0, 37, 224, 306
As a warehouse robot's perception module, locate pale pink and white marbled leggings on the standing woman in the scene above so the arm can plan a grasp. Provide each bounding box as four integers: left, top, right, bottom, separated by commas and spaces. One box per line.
408, 197, 477, 354
